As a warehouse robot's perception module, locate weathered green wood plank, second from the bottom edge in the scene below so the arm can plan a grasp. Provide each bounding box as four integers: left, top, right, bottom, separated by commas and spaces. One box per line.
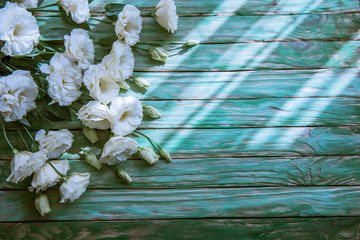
0, 187, 360, 222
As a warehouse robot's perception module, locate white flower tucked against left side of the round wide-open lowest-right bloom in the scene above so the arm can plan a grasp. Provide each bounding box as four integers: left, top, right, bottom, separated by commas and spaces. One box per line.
78, 101, 112, 130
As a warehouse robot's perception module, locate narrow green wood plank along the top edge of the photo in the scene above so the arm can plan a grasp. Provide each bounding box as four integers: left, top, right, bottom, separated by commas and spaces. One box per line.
91, 0, 360, 16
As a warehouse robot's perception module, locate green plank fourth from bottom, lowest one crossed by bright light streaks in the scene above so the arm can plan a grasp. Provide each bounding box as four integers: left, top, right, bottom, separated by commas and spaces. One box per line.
0, 126, 360, 159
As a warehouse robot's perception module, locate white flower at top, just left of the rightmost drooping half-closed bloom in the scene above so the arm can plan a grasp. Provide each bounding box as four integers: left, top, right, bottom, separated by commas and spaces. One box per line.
115, 4, 142, 46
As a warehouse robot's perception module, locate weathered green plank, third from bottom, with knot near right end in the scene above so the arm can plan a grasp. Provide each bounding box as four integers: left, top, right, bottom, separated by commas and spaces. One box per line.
0, 156, 360, 189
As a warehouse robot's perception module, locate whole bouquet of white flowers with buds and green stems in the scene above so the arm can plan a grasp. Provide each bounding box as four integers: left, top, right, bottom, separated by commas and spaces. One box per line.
0, 0, 199, 216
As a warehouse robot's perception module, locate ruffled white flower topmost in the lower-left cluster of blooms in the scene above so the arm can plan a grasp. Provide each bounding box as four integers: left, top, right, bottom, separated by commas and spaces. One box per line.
35, 129, 74, 158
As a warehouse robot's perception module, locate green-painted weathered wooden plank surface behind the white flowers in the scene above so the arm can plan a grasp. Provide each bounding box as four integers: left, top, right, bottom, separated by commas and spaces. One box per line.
0, 0, 360, 239
